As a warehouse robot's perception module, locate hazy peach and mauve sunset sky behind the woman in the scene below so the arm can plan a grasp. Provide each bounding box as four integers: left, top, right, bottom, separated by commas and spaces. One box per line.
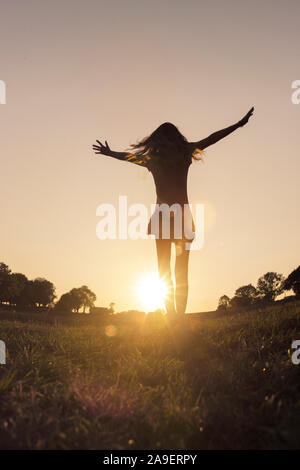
0, 0, 300, 312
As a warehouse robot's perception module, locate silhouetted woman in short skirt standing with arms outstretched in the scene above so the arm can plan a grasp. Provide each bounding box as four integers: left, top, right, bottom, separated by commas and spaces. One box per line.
93, 108, 254, 314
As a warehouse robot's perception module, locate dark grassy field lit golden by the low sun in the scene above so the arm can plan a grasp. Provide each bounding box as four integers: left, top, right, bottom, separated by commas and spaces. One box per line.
0, 304, 300, 449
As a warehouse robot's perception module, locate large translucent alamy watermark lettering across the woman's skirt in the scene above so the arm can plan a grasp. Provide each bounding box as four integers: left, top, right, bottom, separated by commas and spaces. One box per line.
96, 196, 204, 250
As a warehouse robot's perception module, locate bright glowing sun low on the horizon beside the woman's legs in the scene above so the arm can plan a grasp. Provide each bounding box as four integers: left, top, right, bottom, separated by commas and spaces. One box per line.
138, 274, 168, 312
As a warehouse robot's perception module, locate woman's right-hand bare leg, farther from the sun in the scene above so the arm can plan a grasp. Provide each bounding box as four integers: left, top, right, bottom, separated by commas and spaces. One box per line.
175, 240, 190, 315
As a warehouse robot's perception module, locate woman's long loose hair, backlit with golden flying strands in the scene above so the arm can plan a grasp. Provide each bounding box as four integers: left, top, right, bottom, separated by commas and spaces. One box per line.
128, 122, 202, 163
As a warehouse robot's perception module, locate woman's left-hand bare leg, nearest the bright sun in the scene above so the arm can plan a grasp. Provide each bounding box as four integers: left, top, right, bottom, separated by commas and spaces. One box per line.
156, 238, 175, 313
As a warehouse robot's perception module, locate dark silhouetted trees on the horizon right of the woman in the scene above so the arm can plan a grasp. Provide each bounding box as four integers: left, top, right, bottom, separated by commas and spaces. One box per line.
218, 266, 300, 310
